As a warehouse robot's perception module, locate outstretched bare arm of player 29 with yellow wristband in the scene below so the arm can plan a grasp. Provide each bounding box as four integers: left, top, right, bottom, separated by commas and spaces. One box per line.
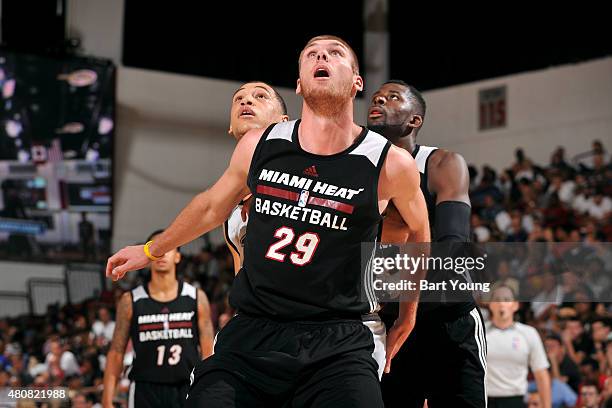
106, 129, 264, 280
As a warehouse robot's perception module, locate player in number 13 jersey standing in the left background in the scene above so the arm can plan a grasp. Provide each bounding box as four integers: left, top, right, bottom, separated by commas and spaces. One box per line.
102, 231, 213, 408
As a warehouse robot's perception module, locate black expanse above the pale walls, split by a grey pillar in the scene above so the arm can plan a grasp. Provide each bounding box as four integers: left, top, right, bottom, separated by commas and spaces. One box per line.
123, 0, 612, 90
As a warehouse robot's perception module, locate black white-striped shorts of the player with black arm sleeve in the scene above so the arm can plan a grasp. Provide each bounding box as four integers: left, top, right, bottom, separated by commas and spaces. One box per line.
381, 308, 487, 408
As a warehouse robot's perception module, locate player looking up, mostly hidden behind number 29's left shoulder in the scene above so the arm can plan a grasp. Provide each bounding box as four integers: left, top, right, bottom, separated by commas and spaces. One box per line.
223, 81, 289, 273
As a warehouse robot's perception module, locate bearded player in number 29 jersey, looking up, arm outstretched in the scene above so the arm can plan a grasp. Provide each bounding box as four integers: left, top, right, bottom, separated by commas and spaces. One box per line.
107, 36, 429, 408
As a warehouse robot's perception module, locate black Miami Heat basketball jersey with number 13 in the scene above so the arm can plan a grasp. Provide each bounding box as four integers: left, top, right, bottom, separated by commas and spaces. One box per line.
129, 281, 200, 384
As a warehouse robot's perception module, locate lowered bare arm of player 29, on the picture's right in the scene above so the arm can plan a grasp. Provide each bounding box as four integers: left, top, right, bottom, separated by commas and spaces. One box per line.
379, 146, 430, 372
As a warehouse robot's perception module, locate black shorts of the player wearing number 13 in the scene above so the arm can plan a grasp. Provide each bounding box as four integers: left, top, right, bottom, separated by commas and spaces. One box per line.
128, 381, 189, 408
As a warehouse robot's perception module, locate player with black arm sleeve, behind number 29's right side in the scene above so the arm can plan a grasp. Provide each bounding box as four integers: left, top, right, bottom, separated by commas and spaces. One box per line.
368, 80, 486, 408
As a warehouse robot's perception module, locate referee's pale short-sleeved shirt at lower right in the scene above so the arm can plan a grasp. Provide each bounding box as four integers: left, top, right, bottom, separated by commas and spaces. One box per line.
486, 322, 549, 397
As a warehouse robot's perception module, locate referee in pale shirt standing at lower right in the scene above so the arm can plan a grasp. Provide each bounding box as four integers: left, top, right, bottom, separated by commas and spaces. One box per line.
486, 285, 551, 408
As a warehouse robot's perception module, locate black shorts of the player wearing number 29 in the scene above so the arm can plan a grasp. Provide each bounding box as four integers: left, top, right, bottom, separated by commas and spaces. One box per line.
185, 314, 383, 408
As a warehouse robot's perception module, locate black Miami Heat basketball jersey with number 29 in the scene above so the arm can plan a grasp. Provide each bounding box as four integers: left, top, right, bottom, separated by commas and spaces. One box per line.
230, 120, 390, 320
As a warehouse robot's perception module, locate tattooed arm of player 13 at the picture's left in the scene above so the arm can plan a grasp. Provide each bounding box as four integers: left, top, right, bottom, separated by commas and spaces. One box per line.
102, 292, 132, 408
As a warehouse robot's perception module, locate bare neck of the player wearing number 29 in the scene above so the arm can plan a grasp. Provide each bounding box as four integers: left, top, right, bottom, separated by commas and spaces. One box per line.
298, 100, 361, 155
